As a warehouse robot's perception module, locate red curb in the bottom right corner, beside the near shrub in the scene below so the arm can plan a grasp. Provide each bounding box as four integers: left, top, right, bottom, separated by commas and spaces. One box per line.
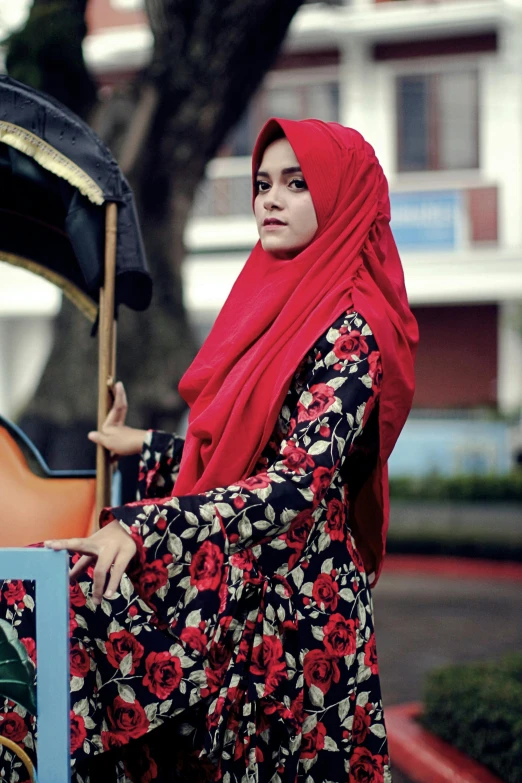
385, 702, 502, 783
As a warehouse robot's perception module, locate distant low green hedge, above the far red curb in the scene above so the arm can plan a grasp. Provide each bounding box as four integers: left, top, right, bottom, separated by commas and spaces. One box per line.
390, 471, 522, 502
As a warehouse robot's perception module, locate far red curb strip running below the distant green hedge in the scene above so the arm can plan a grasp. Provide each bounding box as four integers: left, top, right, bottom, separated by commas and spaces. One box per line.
383, 555, 522, 582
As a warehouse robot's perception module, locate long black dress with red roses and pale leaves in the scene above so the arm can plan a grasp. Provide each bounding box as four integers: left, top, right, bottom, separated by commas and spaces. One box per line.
0, 311, 391, 783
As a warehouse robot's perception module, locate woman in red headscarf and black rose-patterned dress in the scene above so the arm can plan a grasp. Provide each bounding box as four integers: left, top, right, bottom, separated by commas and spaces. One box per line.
0, 119, 417, 783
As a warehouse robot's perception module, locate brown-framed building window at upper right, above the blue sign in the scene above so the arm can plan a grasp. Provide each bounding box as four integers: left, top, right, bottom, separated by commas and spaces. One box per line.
397, 71, 479, 171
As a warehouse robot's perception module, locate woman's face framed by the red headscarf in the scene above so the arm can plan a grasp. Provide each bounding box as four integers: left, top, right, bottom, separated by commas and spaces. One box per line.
254, 138, 317, 258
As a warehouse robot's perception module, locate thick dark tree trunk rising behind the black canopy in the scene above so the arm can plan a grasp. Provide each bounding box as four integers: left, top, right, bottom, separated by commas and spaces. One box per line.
10, 0, 301, 468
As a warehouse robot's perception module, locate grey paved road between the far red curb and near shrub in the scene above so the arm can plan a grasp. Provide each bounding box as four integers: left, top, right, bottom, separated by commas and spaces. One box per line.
373, 566, 522, 783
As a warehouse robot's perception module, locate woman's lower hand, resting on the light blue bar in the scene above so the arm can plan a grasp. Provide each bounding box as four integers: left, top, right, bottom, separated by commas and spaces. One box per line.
44, 522, 137, 604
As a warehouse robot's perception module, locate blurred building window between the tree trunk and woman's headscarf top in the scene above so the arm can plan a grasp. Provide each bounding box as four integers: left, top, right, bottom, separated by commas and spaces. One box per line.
219, 80, 339, 156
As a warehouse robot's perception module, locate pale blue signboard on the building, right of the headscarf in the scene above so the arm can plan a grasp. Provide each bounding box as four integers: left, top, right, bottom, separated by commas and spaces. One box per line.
390, 190, 462, 250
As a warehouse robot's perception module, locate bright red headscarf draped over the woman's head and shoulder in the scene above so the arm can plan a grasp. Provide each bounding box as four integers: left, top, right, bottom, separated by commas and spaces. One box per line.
174, 119, 418, 584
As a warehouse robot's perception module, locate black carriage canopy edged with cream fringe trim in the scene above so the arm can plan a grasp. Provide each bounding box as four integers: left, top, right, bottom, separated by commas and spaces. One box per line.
0, 75, 152, 320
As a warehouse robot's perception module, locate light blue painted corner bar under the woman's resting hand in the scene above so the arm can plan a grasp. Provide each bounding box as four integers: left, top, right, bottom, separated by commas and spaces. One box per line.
0, 548, 70, 783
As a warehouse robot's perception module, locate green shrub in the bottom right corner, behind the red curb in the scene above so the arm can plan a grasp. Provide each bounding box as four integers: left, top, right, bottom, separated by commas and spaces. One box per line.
421, 653, 522, 783
